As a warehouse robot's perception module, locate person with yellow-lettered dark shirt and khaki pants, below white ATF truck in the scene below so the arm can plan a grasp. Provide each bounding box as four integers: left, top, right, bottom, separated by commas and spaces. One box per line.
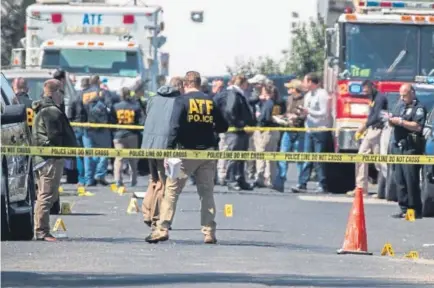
112, 87, 143, 187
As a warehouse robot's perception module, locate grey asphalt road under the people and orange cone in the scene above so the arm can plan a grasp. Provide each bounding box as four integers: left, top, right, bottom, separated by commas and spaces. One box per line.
1, 164, 434, 288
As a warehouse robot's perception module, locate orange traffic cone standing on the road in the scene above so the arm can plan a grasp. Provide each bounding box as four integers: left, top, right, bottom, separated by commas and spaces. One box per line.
337, 188, 372, 255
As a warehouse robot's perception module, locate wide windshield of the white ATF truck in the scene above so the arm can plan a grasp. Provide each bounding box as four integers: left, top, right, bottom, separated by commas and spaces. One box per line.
42, 49, 139, 77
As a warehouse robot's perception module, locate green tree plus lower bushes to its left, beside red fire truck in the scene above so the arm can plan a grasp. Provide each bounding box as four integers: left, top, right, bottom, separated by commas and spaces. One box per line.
227, 16, 326, 77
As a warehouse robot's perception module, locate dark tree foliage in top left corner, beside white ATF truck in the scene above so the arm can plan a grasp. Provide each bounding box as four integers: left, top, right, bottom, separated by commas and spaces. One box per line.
1, 0, 35, 66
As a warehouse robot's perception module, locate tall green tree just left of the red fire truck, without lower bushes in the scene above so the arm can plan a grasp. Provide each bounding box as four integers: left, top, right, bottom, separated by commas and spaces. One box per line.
284, 16, 326, 77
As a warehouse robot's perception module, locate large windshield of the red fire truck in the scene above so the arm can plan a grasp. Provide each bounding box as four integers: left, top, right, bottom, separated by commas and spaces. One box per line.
344, 23, 434, 81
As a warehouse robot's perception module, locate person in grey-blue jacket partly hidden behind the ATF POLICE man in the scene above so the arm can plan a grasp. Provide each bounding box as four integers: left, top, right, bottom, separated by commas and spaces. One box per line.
142, 77, 184, 228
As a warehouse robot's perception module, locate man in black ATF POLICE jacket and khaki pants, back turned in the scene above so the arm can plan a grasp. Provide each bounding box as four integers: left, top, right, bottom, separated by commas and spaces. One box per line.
146, 71, 228, 244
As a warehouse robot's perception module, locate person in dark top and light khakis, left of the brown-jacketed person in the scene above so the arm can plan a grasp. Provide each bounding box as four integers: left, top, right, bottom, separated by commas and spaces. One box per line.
253, 84, 282, 188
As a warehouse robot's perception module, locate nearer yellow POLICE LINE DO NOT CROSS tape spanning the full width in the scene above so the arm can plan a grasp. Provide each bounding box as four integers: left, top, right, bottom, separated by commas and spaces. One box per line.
1, 146, 434, 164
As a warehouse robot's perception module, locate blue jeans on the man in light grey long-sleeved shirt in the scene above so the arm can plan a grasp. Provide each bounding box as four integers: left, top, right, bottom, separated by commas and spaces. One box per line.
298, 132, 330, 189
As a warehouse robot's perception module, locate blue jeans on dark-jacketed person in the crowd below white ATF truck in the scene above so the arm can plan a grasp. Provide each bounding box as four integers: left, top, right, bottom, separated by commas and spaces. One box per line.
83, 132, 108, 184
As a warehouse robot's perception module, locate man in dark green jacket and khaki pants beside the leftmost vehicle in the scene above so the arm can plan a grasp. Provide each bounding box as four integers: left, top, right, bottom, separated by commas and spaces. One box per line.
32, 79, 78, 241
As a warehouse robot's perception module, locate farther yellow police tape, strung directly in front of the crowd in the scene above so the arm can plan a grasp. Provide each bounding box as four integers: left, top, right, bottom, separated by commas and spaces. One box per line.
71, 122, 346, 132
